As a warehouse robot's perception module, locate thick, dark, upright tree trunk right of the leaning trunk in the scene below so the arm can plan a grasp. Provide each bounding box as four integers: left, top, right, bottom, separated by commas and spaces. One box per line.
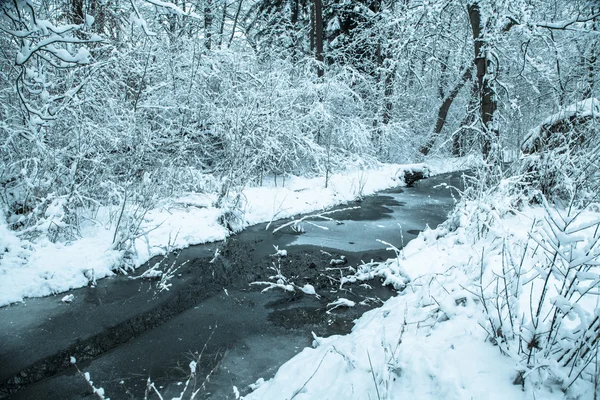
467, 2, 498, 157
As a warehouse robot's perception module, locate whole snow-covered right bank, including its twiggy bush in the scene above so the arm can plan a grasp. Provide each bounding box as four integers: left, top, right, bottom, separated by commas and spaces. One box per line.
241, 185, 600, 400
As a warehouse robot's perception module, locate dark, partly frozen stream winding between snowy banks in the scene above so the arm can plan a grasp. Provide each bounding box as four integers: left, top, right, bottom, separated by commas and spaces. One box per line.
0, 173, 461, 400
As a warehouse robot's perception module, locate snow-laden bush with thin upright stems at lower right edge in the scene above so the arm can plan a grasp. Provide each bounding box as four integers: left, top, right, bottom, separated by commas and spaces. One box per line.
481, 202, 600, 391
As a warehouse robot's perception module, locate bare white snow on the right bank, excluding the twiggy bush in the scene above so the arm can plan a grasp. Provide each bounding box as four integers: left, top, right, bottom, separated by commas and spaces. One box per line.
244, 199, 600, 400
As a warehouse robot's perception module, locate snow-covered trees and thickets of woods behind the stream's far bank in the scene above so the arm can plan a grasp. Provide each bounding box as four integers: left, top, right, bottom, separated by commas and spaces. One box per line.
0, 0, 599, 225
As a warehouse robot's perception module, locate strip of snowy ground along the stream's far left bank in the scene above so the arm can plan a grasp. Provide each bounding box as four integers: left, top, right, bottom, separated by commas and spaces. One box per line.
0, 159, 474, 306
